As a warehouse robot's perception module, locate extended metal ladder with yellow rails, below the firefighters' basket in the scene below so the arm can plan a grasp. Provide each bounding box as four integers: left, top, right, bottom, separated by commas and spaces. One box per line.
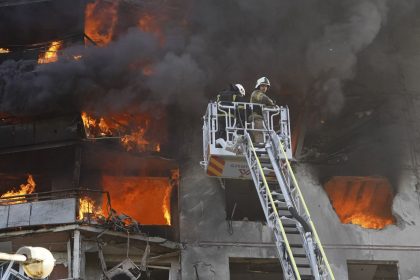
242, 131, 335, 280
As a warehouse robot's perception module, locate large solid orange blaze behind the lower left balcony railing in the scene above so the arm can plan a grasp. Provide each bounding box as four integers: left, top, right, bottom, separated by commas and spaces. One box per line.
102, 175, 172, 225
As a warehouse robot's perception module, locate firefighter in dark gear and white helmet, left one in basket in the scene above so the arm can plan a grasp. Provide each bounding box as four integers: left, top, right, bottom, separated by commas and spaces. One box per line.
216, 84, 245, 140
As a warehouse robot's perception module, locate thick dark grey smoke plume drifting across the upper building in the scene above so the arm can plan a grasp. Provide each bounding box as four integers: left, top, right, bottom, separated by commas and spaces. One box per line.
0, 0, 405, 115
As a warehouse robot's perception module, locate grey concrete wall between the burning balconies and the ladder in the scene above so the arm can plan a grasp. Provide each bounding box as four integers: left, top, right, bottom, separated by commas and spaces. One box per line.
179, 163, 282, 280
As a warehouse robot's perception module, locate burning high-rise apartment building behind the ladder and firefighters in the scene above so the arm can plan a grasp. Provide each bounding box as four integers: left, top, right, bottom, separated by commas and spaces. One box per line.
0, 0, 420, 280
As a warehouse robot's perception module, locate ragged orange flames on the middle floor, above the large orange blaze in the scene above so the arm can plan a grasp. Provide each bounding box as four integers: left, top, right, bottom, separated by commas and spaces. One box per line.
81, 112, 162, 152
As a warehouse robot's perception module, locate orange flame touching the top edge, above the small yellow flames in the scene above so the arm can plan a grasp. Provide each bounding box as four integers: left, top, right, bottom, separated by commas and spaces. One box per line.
85, 0, 119, 46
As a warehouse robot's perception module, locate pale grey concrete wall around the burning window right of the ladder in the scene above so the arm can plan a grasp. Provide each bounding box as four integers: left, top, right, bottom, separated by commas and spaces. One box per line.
297, 166, 420, 279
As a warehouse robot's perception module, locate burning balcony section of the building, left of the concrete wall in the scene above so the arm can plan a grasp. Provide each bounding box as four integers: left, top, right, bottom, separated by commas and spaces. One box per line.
0, 1, 180, 279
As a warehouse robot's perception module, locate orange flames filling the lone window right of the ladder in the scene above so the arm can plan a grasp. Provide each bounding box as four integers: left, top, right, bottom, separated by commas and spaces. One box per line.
325, 176, 395, 229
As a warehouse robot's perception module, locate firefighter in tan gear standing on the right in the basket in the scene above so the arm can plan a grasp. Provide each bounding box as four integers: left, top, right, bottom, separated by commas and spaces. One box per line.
249, 77, 276, 143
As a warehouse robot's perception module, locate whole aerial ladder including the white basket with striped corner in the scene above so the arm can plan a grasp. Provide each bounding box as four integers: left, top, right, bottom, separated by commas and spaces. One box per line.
201, 102, 335, 280
